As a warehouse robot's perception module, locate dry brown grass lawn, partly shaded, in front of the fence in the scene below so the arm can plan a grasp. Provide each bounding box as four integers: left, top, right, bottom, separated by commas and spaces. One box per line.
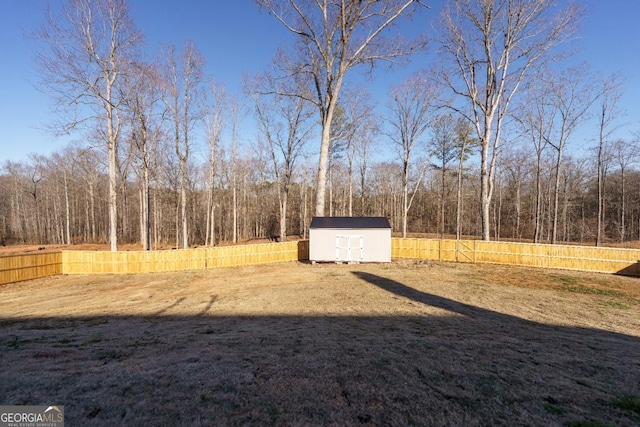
0, 261, 640, 426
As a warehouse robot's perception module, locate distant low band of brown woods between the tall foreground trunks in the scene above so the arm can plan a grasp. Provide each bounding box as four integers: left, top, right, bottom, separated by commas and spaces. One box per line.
0, 139, 640, 247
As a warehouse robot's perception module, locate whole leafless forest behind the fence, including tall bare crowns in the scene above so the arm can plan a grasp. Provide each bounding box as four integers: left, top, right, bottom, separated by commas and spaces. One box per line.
0, 0, 640, 250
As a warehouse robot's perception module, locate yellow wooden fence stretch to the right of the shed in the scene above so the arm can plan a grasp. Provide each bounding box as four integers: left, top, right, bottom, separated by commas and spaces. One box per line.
391, 238, 640, 276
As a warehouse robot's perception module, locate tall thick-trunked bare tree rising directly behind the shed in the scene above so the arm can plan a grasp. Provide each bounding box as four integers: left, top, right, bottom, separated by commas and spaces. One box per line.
257, 0, 420, 216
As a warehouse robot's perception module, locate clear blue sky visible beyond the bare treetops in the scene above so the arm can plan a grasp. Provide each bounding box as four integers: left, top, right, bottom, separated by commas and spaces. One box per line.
0, 0, 640, 164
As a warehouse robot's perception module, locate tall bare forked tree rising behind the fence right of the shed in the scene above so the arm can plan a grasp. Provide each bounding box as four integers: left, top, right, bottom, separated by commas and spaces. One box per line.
440, 0, 580, 240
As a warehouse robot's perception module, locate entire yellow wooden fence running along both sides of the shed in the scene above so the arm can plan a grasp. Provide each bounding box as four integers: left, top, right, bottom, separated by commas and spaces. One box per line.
0, 238, 640, 284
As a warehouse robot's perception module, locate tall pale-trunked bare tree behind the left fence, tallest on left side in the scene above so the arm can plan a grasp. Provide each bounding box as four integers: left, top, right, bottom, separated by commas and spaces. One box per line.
36, 0, 142, 251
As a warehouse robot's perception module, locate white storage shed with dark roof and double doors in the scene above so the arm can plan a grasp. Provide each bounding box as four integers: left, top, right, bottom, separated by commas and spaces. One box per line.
309, 217, 391, 262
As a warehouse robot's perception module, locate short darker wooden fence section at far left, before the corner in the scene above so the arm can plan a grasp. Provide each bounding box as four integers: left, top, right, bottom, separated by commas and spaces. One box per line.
0, 252, 62, 285
